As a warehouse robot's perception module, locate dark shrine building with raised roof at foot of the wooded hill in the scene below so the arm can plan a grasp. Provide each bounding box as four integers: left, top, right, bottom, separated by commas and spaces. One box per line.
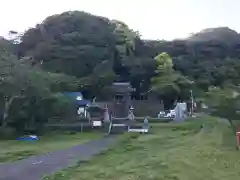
109, 82, 164, 117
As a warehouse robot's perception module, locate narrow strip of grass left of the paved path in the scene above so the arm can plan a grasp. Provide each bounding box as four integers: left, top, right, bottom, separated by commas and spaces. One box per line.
0, 132, 102, 163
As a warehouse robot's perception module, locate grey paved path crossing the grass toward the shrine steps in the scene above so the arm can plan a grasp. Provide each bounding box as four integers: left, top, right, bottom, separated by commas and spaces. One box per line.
0, 136, 116, 180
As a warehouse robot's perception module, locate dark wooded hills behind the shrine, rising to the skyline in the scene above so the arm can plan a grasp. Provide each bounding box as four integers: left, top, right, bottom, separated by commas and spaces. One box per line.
14, 11, 240, 92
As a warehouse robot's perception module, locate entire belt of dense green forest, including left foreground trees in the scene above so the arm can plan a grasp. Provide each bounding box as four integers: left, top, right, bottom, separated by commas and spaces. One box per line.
0, 11, 240, 135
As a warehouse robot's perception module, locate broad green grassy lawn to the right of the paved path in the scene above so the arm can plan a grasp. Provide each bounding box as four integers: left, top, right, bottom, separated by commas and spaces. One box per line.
45, 117, 240, 180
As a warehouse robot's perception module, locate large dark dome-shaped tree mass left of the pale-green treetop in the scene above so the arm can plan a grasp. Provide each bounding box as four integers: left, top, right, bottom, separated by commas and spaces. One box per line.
20, 11, 117, 77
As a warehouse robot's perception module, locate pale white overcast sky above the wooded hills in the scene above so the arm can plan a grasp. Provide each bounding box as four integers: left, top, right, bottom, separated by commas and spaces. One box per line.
0, 0, 240, 40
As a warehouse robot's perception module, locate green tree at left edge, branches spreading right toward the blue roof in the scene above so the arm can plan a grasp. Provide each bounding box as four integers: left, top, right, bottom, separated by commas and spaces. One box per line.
0, 45, 82, 127
